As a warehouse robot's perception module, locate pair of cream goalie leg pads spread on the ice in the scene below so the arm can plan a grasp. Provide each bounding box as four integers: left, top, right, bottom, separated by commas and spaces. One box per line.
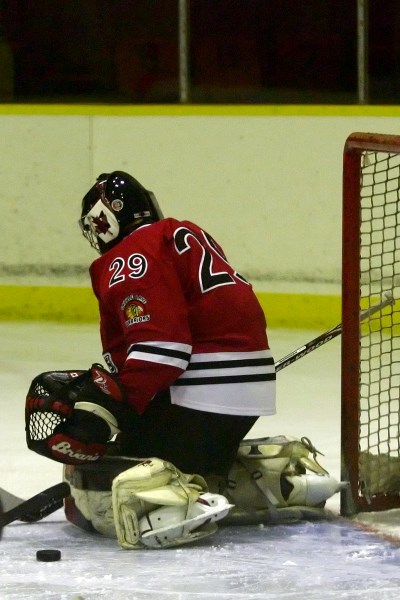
64, 436, 341, 549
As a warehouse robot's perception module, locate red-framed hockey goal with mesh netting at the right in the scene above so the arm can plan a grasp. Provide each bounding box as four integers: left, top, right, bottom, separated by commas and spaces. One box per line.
341, 133, 400, 516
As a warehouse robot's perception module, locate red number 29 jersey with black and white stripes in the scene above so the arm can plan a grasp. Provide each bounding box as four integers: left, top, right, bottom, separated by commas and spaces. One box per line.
90, 218, 275, 416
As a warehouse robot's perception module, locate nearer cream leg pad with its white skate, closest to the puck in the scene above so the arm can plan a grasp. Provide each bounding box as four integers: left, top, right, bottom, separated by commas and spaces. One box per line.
112, 458, 232, 550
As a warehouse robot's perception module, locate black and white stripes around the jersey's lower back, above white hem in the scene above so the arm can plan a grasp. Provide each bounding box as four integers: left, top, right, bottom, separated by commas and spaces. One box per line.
174, 350, 276, 386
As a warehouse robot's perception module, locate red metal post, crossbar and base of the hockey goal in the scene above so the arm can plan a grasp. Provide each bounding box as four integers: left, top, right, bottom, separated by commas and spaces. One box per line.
340, 132, 400, 516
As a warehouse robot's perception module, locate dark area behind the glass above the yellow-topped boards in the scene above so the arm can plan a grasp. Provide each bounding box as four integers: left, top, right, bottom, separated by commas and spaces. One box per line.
0, 0, 400, 104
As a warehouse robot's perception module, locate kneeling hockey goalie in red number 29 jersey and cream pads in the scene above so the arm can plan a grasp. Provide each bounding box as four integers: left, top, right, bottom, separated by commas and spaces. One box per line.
26, 171, 339, 548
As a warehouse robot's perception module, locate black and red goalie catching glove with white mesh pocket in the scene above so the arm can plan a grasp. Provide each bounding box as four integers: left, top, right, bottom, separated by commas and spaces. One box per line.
25, 364, 132, 464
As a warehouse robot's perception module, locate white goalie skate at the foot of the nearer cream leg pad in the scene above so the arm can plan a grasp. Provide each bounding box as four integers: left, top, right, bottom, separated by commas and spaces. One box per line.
139, 492, 232, 548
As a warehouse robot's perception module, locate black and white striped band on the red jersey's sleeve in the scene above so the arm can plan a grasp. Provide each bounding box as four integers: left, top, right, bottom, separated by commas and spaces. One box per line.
128, 342, 192, 370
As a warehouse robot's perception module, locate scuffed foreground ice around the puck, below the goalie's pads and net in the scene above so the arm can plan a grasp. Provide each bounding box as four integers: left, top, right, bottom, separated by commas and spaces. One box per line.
0, 511, 400, 600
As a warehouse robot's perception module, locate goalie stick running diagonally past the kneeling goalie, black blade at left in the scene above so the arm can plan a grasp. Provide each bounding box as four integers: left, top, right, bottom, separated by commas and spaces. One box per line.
0, 292, 395, 536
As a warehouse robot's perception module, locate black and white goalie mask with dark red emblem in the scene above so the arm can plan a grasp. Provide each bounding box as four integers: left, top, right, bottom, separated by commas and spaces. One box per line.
79, 171, 164, 254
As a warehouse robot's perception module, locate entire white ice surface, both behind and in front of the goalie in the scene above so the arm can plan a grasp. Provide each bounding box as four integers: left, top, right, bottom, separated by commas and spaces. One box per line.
0, 322, 400, 600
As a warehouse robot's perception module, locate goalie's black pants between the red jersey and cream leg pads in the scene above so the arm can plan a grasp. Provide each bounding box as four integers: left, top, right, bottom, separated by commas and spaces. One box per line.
113, 391, 258, 476
